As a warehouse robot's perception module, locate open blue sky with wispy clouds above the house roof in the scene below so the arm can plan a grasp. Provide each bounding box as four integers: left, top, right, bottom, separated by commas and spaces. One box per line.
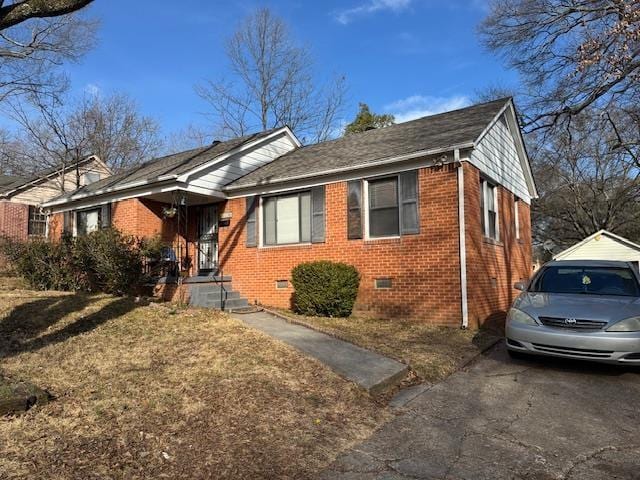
66, 0, 515, 138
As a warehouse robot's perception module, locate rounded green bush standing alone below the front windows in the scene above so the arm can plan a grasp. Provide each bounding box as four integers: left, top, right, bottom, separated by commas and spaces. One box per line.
291, 261, 360, 317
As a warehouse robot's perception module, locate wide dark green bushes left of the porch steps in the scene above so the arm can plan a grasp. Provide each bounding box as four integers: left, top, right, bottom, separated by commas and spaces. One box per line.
0, 229, 143, 295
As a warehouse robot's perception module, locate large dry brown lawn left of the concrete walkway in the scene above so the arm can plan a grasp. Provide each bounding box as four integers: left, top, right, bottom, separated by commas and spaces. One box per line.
0, 288, 389, 479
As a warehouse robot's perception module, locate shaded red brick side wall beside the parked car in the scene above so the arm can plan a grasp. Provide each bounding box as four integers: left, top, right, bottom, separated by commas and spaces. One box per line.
464, 163, 532, 327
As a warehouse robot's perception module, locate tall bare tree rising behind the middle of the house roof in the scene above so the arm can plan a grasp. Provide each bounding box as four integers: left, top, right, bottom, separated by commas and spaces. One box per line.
196, 9, 345, 142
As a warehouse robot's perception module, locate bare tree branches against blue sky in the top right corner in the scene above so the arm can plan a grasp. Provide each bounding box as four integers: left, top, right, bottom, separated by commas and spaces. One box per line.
480, 0, 640, 163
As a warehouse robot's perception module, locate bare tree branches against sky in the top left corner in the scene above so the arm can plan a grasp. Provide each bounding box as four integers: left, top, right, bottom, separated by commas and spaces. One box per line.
0, 0, 97, 101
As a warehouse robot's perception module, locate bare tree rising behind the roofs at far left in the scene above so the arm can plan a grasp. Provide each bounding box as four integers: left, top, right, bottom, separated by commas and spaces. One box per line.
9, 90, 161, 191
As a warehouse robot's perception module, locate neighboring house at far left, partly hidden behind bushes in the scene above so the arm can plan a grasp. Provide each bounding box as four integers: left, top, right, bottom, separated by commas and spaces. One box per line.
0, 156, 111, 240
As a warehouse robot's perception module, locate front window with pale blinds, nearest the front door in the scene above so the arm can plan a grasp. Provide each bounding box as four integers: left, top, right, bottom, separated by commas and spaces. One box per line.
262, 191, 311, 245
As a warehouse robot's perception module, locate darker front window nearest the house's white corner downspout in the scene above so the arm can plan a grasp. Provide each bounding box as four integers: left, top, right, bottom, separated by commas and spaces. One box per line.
368, 177, 400, 237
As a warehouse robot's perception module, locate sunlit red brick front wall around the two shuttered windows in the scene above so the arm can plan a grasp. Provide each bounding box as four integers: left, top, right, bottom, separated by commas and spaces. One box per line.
219, 166, 461, 325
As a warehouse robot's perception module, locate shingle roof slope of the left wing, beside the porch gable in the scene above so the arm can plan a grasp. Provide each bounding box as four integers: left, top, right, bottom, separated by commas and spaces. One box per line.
52, 130, 273, 199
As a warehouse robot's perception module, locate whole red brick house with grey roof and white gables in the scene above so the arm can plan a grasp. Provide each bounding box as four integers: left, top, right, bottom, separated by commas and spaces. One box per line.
46, 99, 536, 326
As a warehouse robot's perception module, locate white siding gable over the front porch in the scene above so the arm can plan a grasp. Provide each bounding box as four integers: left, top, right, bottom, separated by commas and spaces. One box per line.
188, 133, 296, 191
